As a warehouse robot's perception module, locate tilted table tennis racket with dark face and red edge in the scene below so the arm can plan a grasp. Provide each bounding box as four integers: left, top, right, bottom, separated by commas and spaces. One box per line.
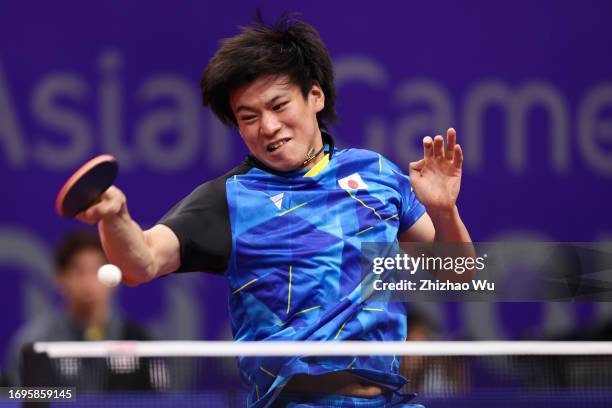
55, 154, 119, 218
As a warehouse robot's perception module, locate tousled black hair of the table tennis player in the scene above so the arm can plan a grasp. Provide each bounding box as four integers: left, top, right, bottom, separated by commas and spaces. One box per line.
200, 14, 337, 129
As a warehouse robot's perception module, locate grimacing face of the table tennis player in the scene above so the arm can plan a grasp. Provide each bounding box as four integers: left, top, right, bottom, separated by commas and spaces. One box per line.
230, 76, 325, 172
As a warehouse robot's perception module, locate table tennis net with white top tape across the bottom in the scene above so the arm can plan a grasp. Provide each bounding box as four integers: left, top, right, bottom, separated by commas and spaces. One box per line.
22, 342, 612, 408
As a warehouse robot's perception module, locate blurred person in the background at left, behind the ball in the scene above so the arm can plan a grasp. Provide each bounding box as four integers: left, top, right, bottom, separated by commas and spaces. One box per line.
6, 231, 157, 390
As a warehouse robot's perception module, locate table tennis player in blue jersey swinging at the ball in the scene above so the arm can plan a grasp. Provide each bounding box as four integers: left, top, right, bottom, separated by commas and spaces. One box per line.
79, 19, 470, 407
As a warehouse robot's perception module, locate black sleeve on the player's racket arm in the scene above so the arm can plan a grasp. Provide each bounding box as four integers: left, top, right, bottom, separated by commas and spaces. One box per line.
158, 165, 248, 274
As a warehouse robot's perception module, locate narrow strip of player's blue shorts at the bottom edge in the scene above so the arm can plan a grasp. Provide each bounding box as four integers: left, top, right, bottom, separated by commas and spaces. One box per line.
272, 392, 425, 408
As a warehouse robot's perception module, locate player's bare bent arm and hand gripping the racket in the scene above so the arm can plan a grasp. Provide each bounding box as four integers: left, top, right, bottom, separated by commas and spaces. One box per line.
77, 186, 180, 286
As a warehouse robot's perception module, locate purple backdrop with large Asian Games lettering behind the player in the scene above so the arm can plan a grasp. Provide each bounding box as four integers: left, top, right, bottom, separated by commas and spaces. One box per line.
0, 1, 612, 364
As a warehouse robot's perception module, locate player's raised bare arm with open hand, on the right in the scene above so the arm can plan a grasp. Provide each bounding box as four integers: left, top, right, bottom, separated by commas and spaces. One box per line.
399, 128, 476, 281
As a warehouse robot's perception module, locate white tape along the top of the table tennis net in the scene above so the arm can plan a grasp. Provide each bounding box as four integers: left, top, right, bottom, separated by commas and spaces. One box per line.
34, 341, 612, 358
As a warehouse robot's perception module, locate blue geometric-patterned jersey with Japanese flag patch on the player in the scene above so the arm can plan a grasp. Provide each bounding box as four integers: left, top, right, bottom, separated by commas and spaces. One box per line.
225, 145, 425, 407
